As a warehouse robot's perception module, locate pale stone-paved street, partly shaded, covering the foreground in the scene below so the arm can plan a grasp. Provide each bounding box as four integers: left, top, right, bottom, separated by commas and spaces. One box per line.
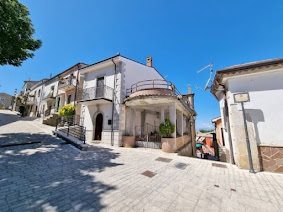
0, 111, 283, 212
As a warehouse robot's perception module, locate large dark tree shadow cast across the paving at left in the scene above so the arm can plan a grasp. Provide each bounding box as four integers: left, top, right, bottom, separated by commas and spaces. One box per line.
0, 133, 123, 211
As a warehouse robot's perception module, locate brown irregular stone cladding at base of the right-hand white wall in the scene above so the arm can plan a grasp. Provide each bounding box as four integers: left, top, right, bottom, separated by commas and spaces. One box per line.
259, 146, 283, 172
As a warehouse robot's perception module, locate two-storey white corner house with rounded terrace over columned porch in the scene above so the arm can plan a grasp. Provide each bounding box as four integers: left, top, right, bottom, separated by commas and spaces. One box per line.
77, 55, 196, 154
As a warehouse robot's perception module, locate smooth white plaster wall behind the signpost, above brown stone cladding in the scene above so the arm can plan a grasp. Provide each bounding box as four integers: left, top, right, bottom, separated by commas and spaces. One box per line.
225, 70, 283, 145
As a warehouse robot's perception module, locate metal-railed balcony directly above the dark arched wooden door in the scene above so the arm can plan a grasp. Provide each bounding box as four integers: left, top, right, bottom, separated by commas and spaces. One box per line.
77, 85, 113, 102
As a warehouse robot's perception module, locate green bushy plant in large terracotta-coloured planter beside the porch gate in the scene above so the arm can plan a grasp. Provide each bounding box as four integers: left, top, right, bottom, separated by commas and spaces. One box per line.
159, 119, 176, 153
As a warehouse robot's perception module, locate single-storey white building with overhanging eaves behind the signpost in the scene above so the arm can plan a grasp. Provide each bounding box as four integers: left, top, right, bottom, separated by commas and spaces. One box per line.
211, 58, 283, 172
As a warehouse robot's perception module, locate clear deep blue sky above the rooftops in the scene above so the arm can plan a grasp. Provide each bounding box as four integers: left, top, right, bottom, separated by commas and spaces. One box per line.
0, 0, 283, 128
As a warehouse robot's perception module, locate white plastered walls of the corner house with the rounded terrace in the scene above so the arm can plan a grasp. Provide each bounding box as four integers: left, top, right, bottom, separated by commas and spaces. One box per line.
82, 57, 166, 144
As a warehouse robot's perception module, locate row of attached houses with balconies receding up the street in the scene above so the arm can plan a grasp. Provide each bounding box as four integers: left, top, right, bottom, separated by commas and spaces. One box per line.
23, 63, 86, 126
